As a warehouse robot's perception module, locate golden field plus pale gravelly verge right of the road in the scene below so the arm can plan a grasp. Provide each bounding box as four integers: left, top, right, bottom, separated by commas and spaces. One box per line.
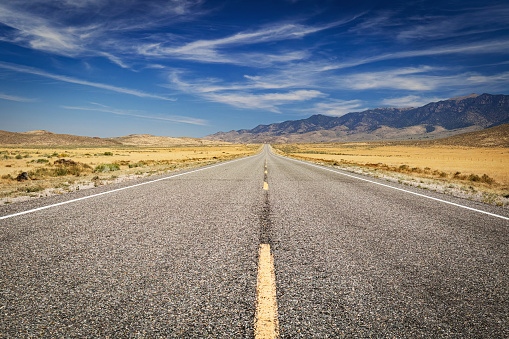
272, 142, 509, 207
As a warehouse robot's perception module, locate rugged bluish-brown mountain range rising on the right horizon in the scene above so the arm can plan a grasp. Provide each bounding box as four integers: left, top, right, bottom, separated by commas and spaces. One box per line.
205, 93, 509, 143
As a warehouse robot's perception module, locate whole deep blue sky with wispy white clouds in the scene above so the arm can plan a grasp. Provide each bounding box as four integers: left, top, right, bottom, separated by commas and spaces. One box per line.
0, 0, 509, 137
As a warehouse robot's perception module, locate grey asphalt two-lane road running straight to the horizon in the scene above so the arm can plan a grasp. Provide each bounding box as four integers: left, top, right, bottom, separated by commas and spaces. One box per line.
0, 147, 509, 338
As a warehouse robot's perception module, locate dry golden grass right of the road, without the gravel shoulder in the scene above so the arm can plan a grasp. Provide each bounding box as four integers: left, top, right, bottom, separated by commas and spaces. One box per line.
273, 142, 509, 203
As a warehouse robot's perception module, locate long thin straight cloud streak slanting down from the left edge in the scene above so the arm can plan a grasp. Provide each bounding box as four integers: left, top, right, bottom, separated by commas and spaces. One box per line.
0, 62, 175, 101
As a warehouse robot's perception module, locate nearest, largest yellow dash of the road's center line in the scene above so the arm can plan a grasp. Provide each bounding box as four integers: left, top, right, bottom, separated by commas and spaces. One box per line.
255, 244, 279, 339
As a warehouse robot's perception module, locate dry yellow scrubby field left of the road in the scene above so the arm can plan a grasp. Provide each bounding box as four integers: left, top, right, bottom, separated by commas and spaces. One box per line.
0, 145, 260, 203
